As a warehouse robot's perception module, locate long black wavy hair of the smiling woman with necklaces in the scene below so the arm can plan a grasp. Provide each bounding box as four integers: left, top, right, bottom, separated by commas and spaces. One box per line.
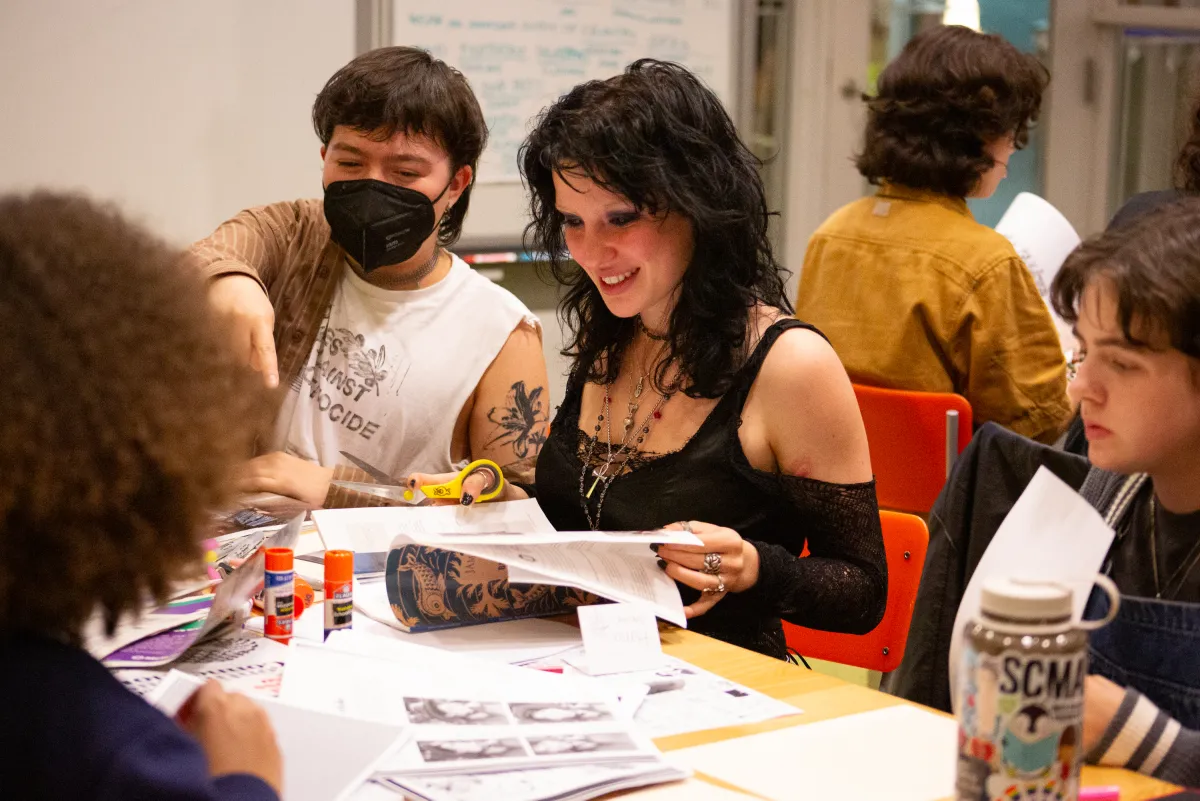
520, 59, 792, 398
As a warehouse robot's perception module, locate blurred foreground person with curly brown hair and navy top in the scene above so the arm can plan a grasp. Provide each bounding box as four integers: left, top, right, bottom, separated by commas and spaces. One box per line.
0, 194, 282, 801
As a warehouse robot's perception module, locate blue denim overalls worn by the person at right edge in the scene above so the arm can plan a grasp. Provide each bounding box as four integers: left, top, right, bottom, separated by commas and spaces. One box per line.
1084, 476, 1200, 729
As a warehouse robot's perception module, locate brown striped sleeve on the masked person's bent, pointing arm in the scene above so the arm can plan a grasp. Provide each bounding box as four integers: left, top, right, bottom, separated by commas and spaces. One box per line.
184, 201, 307, 291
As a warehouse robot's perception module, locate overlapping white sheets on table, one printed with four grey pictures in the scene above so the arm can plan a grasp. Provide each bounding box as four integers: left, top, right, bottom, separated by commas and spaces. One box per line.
280, 632, 686, 800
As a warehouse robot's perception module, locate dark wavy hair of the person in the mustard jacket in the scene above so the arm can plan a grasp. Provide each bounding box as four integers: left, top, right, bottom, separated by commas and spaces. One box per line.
856, 25, 1050, 198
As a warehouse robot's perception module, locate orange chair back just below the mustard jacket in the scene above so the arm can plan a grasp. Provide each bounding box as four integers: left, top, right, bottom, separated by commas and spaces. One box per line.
854, 384, 972, 514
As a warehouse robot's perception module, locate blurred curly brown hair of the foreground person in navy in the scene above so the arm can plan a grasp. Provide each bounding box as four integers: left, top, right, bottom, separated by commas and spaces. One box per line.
0, 193, 269, 642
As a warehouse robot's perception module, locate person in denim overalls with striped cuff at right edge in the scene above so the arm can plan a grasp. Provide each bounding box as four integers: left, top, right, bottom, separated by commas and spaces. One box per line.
1051, 199, 1200, 787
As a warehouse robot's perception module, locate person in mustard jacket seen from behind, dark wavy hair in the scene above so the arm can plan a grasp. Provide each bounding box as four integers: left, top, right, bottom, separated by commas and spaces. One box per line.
796, 25, 1070, 441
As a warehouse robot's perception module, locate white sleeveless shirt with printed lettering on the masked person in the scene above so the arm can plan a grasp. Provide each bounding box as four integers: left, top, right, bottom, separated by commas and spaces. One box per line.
275, 254, 540, 478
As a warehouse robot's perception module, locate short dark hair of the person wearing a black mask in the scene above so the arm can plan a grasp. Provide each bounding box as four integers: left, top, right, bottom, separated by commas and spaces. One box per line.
312, 47, 487, 247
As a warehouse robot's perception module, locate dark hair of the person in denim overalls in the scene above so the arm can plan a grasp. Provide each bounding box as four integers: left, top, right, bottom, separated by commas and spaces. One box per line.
1050, 198, 1200, 359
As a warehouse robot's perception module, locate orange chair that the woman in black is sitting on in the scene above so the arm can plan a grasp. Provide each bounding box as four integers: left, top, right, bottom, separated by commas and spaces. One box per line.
784, 512, 929, 673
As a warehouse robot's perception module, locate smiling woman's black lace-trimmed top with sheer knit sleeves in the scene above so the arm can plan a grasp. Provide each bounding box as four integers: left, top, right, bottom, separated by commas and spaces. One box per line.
536, 319, 887, 658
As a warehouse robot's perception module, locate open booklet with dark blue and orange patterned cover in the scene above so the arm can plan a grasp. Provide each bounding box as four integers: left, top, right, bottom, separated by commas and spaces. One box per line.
313, 500, 701, 631
